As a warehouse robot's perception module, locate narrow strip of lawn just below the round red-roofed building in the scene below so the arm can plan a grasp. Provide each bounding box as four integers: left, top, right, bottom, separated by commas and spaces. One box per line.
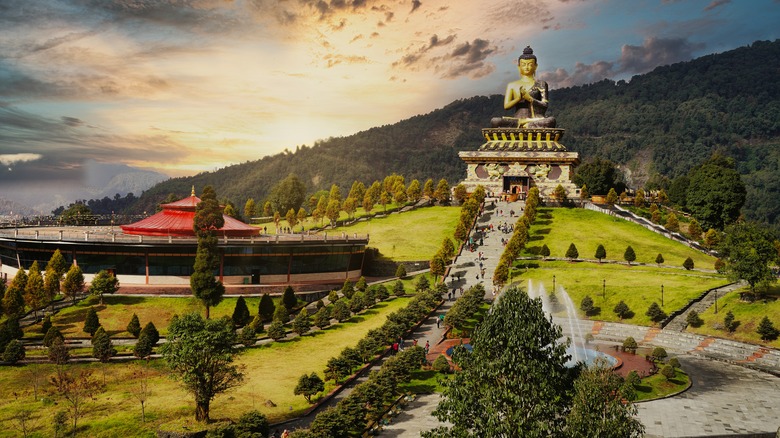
25, 295, 278, 338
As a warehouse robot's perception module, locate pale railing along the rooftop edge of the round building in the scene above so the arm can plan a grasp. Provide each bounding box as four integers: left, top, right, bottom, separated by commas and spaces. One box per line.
0, 227, 369, 244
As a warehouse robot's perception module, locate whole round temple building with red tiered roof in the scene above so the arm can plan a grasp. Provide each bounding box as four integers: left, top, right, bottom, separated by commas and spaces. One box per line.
0, 188, 368, 288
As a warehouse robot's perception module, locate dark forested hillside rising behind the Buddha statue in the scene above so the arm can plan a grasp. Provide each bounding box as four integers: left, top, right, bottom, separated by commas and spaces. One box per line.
128, 41, 780, 227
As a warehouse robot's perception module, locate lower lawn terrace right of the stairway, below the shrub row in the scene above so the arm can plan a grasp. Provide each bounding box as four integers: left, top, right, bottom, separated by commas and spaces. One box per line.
512, 261, 728, 325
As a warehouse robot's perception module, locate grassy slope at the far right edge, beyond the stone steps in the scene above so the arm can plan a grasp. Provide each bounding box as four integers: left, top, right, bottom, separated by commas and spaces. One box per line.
687, 285, 780, 348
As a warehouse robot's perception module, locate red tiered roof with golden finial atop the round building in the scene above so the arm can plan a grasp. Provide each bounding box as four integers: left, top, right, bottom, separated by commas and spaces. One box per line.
121, 189, 260, 237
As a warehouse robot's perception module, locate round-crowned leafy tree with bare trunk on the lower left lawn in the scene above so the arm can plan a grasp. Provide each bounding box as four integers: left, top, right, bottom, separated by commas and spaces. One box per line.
160, 313, 244, 422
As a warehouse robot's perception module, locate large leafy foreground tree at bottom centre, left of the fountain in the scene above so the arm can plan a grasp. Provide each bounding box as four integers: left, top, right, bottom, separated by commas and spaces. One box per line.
423, 287, 572, 438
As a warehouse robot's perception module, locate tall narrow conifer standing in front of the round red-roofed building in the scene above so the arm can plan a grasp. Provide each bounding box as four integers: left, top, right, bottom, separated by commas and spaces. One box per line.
190, 186, 225, 319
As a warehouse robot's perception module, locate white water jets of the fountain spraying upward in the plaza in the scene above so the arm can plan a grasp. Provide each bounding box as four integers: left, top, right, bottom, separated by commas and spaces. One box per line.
528, 280, 618, 367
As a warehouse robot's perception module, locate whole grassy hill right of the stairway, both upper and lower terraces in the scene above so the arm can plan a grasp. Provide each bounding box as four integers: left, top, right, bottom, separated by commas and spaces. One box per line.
512, 208, 728, 325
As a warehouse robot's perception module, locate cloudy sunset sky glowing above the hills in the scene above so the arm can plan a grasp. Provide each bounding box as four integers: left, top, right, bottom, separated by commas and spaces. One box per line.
0, 0, 780, 196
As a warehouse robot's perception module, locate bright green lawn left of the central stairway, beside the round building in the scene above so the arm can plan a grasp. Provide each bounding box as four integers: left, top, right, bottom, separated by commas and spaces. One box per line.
328, 207, 460, 261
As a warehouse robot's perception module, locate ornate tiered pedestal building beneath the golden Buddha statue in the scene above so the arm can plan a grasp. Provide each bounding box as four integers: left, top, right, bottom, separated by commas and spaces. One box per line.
458, 128, 580, 201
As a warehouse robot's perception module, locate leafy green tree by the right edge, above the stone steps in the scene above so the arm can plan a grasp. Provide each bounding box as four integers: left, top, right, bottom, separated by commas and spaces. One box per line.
708, 221, 777, 295
